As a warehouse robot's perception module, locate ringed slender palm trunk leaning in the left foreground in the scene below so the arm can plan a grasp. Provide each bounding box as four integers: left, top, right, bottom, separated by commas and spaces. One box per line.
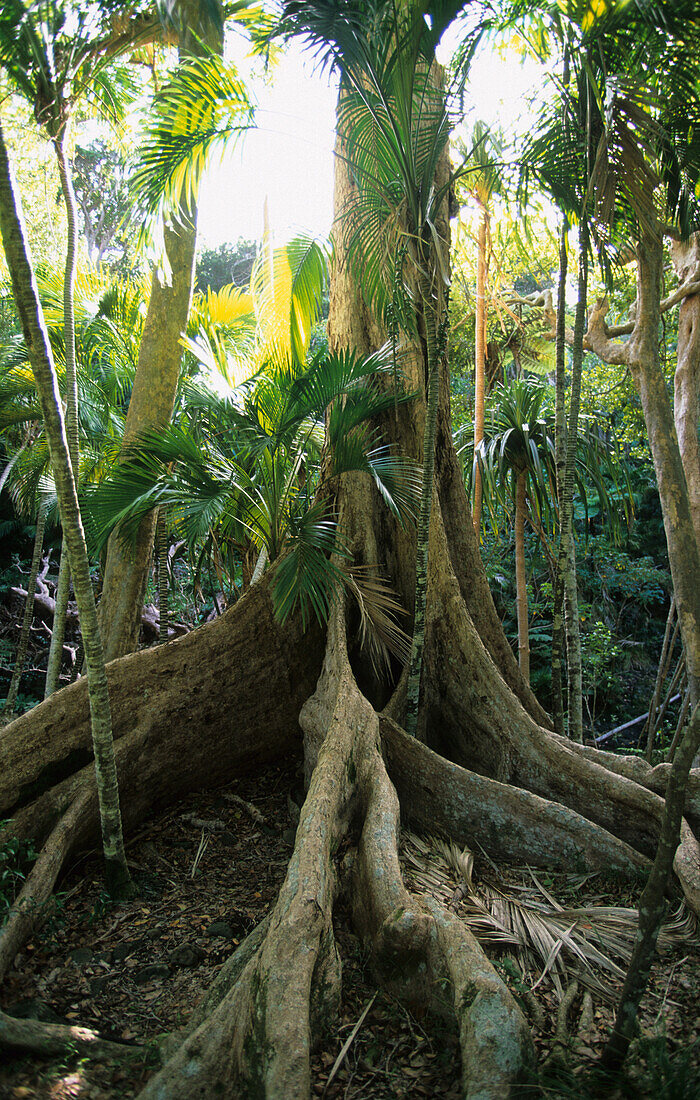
0, 124, 129, 893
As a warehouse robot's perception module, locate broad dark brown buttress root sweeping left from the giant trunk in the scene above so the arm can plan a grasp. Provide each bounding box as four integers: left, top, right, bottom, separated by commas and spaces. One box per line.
0, 579, 322, 817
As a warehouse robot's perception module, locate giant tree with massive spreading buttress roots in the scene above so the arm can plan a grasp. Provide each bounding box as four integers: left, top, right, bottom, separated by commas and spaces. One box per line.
0, 0, 700, 1100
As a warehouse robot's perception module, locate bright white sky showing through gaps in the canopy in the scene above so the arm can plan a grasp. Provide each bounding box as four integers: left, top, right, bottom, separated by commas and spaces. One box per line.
199, 35, 542, 248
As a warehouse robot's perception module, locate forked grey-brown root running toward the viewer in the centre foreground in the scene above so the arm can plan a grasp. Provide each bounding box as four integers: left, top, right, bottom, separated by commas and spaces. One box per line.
135, 608, 531, 1100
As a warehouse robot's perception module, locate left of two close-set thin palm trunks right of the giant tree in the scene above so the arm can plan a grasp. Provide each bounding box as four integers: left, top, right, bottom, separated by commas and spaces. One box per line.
551, 219, 569, 734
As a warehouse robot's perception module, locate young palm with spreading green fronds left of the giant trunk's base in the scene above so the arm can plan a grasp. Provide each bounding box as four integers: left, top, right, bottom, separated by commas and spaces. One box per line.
86, 351, 414, 638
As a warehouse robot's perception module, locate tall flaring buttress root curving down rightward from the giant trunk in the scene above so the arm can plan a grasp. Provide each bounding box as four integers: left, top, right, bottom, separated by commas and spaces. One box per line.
413, 514, 700, 915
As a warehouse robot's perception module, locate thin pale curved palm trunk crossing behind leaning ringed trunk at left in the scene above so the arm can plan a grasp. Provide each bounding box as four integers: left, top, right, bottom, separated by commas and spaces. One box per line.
44, 123, 80, 699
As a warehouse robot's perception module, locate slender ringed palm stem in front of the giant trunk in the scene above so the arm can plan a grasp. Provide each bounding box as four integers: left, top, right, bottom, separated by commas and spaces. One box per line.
404, 278, 439, 737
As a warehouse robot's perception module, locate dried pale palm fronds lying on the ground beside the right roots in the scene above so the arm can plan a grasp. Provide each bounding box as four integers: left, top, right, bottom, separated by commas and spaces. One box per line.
402, 833, 697, 1000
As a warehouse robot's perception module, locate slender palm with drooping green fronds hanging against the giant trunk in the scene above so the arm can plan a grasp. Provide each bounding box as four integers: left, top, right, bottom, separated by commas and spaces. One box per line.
282, 0, 486, 735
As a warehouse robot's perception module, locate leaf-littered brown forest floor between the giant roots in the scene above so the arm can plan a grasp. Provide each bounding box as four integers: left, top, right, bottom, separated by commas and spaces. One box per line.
0, 761, 700, 1100
